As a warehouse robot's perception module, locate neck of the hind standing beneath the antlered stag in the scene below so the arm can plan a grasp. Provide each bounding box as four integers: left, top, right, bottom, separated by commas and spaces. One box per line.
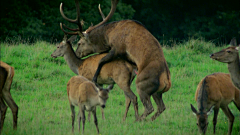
64, 44, 84, 75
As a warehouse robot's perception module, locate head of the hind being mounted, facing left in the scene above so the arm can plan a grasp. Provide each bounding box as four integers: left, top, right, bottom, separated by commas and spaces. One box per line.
51, 30, 77, 58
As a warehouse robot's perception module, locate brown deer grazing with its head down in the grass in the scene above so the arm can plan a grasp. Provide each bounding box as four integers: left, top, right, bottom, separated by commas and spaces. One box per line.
191, 73, 240, 135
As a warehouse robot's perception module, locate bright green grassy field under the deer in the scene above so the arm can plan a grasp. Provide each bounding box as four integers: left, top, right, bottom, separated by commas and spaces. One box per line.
1, 40, 240, 135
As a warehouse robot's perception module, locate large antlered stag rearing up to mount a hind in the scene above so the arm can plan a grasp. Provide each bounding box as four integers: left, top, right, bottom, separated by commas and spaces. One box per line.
60, 0, 171, 120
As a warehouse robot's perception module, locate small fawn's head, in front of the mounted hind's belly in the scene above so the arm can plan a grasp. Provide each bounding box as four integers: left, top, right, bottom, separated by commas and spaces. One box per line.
98, 85, 113, 108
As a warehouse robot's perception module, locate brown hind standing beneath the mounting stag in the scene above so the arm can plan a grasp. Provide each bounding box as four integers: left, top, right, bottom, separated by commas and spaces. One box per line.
51, 30, 138, 120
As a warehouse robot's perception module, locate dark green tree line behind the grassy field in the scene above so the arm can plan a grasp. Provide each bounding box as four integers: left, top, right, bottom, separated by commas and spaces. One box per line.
0, 0, 240, 43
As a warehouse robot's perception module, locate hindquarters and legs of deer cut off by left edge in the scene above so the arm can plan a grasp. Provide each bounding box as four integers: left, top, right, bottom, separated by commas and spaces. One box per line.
0, 61, 18, 133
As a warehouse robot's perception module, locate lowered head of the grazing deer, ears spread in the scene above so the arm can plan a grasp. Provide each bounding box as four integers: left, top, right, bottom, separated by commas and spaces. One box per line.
191, 104, 214, 134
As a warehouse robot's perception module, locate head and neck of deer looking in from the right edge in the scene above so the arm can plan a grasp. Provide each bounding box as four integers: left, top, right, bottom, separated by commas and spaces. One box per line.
210, 38, 240, 89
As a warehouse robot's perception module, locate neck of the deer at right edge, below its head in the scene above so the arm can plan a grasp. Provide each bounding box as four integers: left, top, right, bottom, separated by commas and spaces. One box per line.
228, 55, 240, 89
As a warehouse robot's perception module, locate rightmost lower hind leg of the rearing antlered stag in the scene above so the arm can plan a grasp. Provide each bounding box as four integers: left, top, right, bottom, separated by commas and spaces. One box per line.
151, 92, 166, 121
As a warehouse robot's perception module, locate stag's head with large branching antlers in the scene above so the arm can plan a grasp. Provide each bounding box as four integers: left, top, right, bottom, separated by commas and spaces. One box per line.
60, 0, 119, 58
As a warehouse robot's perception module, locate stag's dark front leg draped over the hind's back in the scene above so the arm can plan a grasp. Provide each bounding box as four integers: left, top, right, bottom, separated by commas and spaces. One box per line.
92, 49, 115, 84
